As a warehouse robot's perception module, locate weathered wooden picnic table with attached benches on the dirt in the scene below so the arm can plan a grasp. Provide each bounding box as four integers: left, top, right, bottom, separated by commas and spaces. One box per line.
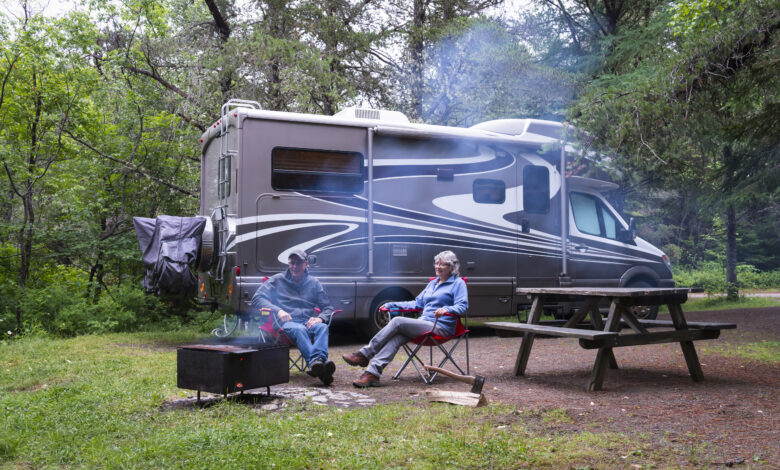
485, 287, 737, 391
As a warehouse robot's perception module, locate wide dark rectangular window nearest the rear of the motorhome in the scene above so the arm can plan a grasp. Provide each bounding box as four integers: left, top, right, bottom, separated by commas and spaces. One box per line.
271, 147, 363, 194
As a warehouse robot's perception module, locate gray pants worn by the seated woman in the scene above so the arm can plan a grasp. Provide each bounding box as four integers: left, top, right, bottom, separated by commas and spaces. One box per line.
360, 317, 443, 377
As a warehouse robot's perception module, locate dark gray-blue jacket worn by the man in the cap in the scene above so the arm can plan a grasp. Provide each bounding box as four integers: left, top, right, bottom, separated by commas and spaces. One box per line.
252, 269, 333, 323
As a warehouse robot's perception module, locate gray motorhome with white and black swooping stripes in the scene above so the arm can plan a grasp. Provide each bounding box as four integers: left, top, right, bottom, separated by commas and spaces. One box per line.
198, 103, 674, 334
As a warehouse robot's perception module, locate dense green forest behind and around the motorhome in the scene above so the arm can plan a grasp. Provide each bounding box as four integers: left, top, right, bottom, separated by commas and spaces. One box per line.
0, 0, 780, 339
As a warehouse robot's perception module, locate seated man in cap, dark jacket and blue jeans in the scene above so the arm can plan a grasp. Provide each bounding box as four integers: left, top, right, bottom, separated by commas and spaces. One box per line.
252, 250, 336, 385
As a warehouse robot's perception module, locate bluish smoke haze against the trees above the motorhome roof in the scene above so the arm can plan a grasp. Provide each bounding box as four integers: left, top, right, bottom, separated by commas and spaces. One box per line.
423, 18, 574, 126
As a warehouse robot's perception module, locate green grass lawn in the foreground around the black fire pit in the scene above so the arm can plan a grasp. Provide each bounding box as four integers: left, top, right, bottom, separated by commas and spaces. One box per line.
0, 332, 748, 468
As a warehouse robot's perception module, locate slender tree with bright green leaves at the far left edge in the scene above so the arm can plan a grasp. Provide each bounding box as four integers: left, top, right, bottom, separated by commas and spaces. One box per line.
0, 8, 97, 330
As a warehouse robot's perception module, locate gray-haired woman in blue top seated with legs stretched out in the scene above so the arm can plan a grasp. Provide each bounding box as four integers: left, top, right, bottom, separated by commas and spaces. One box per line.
341, 251, 469, 388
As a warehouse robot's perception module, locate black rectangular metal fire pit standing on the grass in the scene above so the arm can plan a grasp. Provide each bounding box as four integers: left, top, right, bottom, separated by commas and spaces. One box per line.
176, 344, 290, 403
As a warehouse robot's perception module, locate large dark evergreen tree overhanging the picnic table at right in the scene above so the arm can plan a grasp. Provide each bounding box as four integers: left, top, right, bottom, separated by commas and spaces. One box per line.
574, 0, 780, 295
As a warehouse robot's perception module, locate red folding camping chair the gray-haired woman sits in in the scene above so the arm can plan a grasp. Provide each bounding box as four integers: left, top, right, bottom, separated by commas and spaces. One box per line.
384, 278, 470, 385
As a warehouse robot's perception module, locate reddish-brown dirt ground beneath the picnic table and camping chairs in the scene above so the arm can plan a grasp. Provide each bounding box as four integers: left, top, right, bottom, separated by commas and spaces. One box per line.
290, 307, 780, 468
